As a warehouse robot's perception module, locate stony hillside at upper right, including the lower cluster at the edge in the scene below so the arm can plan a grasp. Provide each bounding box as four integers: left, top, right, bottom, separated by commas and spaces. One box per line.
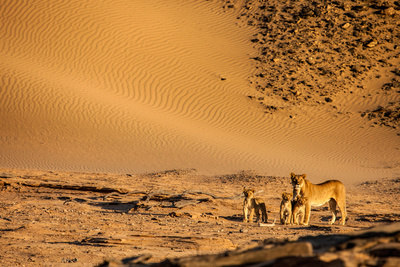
224, 0, 400, 128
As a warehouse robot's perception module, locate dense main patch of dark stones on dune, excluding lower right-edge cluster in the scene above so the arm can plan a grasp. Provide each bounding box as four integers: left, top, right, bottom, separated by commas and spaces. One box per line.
241, 0, 400, 121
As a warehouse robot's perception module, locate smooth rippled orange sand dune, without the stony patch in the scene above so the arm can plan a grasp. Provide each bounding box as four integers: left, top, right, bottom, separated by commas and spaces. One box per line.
0, 0, 400, 183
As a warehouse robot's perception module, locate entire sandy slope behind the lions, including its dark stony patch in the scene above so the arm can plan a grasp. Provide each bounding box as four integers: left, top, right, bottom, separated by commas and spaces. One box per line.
0, 0, 400, 183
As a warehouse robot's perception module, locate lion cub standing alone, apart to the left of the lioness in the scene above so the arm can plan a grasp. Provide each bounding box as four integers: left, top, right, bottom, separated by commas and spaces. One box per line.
243, 188, 268, 223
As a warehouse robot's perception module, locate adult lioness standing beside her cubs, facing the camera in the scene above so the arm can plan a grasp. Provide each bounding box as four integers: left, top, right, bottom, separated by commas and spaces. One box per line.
290, 173, 347, 225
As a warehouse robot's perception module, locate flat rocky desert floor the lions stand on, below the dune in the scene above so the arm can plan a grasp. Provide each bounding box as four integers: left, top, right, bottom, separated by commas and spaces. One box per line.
0, 169, 400, 266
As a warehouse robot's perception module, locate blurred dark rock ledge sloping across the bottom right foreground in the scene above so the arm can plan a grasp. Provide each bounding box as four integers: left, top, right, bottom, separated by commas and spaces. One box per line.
98, 223, 400, 267
